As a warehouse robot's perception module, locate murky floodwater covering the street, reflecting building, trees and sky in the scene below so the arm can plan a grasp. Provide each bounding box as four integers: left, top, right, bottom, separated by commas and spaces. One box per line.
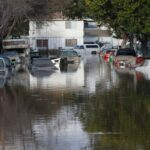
0, 56, 150, 150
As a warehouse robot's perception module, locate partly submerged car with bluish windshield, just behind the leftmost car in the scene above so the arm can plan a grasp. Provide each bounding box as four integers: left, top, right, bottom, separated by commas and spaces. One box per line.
3, 51, 21, 65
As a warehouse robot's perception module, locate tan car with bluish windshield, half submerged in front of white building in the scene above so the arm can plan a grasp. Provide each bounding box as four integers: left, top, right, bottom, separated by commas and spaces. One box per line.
59, 49, 80, 65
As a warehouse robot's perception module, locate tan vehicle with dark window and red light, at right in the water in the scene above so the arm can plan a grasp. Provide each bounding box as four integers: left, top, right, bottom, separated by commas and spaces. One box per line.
113, 48, 144, 68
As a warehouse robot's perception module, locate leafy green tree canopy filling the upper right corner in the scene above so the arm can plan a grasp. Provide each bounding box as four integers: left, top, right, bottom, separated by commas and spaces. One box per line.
85, 0, 150, 53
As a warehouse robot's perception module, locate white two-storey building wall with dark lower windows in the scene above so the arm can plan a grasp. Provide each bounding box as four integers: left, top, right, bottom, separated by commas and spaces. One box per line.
29, 19, 84, 49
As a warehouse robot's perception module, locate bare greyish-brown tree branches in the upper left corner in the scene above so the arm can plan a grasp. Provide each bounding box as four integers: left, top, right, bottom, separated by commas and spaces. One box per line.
0, 0, 66, 39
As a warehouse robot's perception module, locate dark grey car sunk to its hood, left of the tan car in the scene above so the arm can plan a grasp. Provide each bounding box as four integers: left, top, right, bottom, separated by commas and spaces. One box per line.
29, 57, 56, 77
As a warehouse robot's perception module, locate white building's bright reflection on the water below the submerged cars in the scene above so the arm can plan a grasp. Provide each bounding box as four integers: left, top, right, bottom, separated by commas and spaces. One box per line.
30, 62, 84, 90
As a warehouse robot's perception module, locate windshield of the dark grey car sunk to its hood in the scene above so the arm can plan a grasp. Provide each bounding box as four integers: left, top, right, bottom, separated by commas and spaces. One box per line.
33, 59, 53, 67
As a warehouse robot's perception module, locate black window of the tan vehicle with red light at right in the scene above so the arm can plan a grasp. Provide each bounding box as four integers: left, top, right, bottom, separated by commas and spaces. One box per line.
116, 49, 136, 57
